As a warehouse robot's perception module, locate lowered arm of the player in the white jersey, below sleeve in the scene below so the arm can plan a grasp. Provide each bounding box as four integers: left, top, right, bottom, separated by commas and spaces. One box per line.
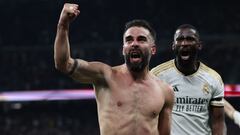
210, 98, 226, 135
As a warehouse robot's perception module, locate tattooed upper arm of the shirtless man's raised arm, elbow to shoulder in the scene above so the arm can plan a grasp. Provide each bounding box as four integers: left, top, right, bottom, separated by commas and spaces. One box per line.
70, 59, 111, 83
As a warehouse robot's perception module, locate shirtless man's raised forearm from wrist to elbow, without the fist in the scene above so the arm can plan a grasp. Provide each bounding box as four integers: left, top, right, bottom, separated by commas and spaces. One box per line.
54, 22, 71, 72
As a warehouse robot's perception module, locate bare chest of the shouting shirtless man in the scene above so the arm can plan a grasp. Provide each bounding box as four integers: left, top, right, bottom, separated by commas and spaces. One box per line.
109, 79, 164, 118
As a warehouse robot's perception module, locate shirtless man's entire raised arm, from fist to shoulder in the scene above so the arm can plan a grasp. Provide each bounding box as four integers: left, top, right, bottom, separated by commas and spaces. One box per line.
54, 3, 110, 83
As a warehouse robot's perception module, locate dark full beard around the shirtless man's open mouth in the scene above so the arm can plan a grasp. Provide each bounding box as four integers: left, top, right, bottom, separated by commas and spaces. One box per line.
124, 51, 150, 72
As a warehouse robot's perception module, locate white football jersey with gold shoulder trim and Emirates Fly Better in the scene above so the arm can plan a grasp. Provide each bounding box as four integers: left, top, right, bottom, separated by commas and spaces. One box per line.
151, 60, 224, 135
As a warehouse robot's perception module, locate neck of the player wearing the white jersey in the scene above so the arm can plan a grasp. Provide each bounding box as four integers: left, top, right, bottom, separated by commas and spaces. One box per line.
174, 58, 200, 75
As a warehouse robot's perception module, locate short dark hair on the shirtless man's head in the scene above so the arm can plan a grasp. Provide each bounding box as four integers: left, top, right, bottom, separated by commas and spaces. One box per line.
123, 19, 156, 42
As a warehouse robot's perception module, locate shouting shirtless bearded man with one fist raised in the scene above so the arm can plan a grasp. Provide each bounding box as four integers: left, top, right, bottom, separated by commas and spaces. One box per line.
54, 3, 174, 135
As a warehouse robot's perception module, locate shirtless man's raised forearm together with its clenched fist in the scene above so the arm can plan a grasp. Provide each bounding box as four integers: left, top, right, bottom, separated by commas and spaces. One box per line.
54, 3, 80, 73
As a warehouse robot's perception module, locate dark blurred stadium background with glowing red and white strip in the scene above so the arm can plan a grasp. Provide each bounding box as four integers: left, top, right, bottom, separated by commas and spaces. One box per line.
0, 0, 240, 135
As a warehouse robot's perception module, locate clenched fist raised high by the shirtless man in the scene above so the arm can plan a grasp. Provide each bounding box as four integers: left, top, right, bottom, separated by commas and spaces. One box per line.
58, 3, 80, 26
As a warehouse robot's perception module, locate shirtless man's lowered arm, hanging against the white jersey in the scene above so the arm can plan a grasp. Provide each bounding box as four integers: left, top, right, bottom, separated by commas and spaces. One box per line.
158, 85, 174, 135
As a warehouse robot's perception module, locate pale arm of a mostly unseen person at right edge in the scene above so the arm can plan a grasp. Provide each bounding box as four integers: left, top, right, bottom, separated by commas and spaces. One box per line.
224, 99, 240, 127
